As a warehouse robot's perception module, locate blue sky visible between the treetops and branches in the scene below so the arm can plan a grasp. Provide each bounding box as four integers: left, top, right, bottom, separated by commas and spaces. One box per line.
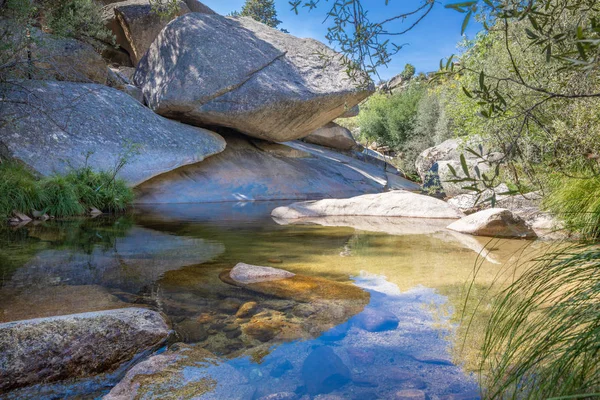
201, 0, 479, 79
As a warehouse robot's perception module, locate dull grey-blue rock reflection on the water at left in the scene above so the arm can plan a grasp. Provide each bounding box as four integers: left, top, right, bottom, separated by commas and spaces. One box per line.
5, 227, 224, 293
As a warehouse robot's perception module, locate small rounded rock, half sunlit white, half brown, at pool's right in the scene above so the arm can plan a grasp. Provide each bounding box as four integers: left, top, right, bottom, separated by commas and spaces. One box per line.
448, 208, 537, 239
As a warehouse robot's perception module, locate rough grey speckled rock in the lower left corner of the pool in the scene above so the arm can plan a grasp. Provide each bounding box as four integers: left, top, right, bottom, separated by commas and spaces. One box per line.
0, 308, 170, 393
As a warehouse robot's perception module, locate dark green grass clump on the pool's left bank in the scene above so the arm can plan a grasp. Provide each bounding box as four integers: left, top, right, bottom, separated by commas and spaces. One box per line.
0, 161, 134, 218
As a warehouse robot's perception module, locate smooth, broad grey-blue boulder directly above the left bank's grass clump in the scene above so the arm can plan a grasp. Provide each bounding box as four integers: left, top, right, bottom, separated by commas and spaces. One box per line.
0, 81, 225, 186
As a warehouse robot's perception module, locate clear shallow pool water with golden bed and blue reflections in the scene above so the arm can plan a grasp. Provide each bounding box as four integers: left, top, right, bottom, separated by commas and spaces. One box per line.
0, 203, 542, 399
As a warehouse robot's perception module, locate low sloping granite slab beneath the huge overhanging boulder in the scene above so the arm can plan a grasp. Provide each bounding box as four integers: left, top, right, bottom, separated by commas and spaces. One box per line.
136, 132, 418, 204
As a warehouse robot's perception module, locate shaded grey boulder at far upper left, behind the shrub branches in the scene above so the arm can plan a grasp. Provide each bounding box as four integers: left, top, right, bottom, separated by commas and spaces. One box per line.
0, 24, 108, 84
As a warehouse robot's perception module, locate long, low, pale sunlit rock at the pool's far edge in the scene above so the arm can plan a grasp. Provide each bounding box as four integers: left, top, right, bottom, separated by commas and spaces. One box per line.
271, 190, 464, 219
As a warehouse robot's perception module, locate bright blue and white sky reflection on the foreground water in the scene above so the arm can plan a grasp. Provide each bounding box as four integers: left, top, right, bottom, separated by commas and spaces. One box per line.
181, 274, 478, 399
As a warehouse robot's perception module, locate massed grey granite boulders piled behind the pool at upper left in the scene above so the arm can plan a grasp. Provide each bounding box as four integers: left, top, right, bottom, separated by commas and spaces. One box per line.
0, 0, 418, 203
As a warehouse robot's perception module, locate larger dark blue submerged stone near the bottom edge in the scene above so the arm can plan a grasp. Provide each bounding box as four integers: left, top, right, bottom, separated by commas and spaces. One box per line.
302, 346, 350, 396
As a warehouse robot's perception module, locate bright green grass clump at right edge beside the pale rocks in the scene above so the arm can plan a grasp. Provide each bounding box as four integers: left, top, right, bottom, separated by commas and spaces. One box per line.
544, 175, 600, 240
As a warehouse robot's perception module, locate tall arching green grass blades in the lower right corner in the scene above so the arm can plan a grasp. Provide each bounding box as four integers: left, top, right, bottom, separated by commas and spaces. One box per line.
481, 245, 600, 399
